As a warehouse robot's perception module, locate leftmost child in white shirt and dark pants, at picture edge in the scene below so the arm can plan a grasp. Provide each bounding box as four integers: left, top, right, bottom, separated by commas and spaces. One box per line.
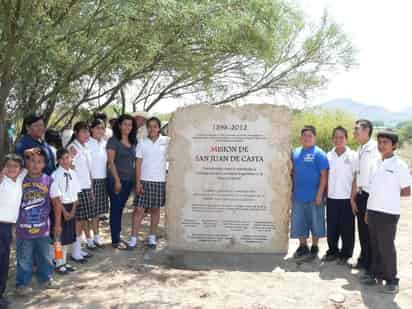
0, 154, 26, 308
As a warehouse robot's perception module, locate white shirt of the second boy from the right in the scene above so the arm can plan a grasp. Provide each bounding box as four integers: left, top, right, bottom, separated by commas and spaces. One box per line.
356, 140, 381, 193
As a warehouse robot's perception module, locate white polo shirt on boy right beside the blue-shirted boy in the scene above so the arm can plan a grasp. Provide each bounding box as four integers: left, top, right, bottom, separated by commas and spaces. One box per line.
327, 147, 356, 200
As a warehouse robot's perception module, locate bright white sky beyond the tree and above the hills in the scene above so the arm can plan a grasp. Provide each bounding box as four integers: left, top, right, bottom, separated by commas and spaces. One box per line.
153, 0, 412, 112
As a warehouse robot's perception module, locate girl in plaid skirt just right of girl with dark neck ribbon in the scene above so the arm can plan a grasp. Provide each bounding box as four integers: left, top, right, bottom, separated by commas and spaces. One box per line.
67, 121, 97, 263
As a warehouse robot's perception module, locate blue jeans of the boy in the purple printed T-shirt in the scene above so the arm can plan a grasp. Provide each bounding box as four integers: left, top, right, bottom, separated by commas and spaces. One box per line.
16, 237, 53, 287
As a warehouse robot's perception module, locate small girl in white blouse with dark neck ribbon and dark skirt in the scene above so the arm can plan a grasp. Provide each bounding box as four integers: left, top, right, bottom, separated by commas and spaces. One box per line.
50, 148, 81, 275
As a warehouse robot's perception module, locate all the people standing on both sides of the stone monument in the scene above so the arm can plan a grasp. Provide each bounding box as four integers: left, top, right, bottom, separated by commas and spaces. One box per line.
0, 113, 412, 306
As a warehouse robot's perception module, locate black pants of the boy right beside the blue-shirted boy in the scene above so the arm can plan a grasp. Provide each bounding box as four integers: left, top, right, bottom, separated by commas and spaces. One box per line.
326, 199, 355, 259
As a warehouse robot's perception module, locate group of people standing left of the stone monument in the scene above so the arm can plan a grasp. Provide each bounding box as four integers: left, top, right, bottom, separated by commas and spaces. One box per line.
0, 113, 169, 307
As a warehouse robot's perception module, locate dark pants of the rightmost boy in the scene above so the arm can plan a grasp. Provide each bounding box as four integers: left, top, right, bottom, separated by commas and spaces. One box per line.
368, 210, 399, 284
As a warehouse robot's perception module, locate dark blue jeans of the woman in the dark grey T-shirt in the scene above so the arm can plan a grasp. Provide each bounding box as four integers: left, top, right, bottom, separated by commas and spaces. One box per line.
107, 178, 133, 244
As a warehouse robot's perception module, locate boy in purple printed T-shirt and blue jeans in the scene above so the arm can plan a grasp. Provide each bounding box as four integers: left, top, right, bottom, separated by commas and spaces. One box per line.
16, 148, 58, 296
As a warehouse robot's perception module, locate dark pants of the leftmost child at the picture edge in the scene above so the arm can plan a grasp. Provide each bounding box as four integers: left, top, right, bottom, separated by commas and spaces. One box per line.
0, 222, 12, 298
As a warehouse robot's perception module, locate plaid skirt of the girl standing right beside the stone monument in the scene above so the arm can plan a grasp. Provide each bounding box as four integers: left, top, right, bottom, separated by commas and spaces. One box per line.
134, 181, 166, 208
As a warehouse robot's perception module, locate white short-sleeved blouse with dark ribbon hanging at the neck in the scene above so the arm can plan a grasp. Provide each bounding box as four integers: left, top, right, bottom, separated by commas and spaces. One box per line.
50, 167, 81, 204
